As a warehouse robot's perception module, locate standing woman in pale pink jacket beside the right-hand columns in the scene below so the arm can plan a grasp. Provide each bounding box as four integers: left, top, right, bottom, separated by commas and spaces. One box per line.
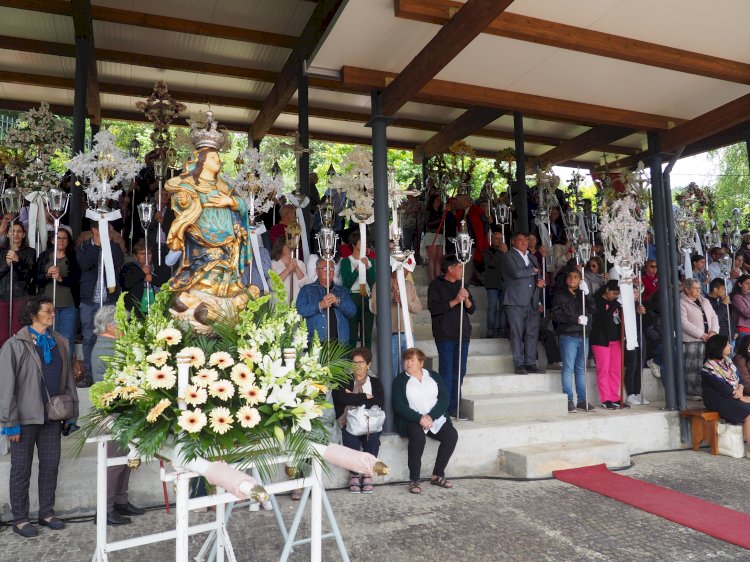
680, 279, 719, 400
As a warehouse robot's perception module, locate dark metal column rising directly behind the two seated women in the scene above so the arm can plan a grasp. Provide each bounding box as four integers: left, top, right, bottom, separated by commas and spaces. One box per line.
368, 91, 395, 433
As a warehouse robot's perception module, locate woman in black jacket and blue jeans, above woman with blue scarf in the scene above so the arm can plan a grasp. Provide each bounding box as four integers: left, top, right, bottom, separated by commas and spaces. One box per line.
36, 228, 81, 360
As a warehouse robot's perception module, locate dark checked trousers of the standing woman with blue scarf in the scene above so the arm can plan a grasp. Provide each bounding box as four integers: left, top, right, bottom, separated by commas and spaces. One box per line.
10, 421, 62, 525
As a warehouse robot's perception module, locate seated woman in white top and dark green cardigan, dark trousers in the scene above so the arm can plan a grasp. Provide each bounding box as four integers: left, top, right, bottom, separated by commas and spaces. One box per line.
393, 348, 458, 494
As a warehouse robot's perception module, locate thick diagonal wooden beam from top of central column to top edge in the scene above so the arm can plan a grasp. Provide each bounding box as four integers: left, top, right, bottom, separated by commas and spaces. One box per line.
381, 0, 513, 116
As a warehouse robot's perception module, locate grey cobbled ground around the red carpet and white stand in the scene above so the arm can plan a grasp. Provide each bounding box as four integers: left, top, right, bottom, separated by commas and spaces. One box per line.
0, 451, 750, 562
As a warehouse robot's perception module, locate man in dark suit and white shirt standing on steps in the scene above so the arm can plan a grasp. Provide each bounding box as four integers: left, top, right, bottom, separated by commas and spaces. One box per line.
502, 232, 544, 375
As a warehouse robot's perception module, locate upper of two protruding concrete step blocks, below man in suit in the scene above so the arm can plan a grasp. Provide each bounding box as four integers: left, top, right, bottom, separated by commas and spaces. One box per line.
461, 390, 568, 422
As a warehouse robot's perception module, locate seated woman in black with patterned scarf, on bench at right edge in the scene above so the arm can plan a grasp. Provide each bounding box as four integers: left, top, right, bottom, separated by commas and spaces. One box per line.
701, 334, 750, 458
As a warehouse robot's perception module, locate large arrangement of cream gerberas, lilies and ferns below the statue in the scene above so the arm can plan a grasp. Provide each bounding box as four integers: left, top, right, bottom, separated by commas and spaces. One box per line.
80, 273, 351, 470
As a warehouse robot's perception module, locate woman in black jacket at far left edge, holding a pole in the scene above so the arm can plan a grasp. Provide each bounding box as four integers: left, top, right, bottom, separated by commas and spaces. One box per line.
0, 222, 36, 345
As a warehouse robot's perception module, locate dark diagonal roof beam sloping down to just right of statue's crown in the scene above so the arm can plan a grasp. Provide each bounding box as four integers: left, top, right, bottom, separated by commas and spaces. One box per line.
252, 0, 346, 140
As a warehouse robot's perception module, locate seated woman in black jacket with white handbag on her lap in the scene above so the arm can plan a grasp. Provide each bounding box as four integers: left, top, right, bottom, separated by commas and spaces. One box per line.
333, 347, 385, 494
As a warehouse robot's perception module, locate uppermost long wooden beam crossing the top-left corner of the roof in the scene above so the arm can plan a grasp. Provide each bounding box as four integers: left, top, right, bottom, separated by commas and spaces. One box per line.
0, 0, 297, 49
